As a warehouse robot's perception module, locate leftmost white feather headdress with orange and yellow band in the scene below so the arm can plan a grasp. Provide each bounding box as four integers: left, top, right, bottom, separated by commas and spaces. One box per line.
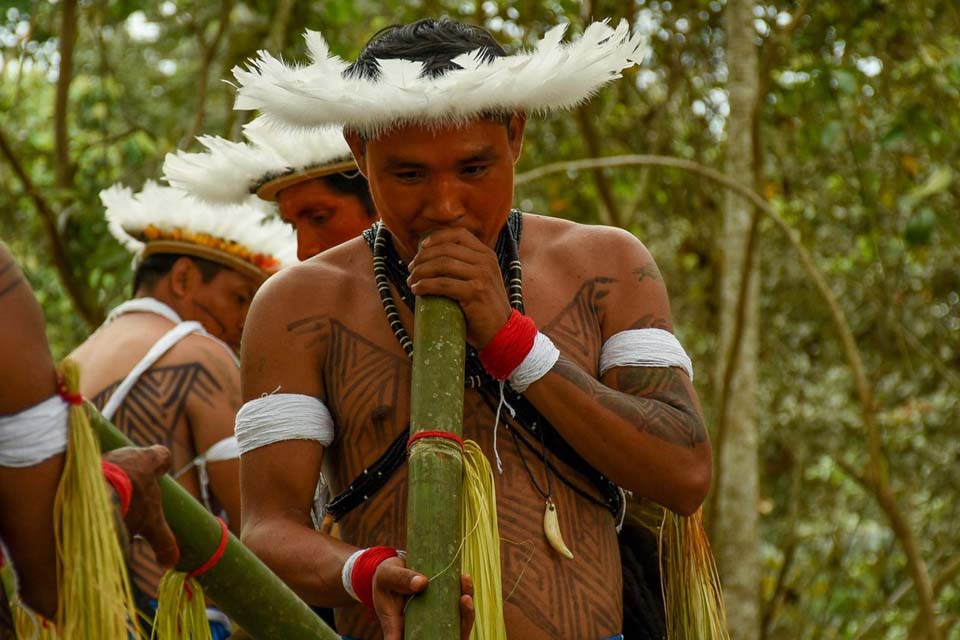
100, 180, 297, 278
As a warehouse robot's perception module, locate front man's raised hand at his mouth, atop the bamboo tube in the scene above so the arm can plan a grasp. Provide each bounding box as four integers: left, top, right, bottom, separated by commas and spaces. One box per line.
407, 228, 510, 349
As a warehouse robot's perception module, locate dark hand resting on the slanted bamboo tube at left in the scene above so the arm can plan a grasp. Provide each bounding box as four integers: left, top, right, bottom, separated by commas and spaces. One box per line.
103, 445, 180, 568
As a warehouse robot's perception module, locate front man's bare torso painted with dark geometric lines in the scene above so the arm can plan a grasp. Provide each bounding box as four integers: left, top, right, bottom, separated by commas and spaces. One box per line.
286, 215, 622, 640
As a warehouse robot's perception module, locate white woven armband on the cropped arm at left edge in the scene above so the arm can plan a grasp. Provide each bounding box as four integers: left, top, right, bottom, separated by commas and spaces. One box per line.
0, 396, 70, 467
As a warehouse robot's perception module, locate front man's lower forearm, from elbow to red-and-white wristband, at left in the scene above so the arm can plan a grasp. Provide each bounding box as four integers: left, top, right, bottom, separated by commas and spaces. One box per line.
241, 520, 357, 607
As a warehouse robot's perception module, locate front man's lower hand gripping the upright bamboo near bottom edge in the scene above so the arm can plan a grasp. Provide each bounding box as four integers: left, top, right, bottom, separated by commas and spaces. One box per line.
373, 558, 474, 640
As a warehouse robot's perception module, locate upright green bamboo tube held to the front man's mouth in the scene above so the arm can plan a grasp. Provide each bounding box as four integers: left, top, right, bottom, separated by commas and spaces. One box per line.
404, 296, 466, 640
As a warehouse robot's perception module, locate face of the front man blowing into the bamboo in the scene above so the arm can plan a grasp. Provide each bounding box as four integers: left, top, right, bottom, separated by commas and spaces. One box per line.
348, 115, 525, 259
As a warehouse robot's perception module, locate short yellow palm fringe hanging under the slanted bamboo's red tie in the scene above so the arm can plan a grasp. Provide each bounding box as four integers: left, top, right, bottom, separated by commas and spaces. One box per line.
150, 571, 212, 640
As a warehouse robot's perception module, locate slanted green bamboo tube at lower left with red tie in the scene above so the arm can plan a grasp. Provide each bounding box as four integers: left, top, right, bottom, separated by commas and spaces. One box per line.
87, 402, 340, 640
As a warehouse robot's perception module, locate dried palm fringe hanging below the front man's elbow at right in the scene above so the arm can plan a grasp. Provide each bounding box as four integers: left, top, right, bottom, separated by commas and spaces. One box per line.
659, 509, 730, 640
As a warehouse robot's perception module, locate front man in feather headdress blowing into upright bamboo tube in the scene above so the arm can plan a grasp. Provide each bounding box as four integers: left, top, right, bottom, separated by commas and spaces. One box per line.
235, 20, 710, 640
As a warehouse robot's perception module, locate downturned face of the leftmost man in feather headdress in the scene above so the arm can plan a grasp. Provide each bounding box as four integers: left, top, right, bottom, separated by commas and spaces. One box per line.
184, 268, 260, 349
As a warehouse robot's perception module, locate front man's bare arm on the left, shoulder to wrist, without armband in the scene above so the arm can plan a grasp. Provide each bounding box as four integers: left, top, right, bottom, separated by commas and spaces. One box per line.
240, 272, 356, 607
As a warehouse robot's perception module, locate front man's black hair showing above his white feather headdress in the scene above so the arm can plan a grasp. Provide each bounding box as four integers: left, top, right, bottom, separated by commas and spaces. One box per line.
344, 18, 507, 80
